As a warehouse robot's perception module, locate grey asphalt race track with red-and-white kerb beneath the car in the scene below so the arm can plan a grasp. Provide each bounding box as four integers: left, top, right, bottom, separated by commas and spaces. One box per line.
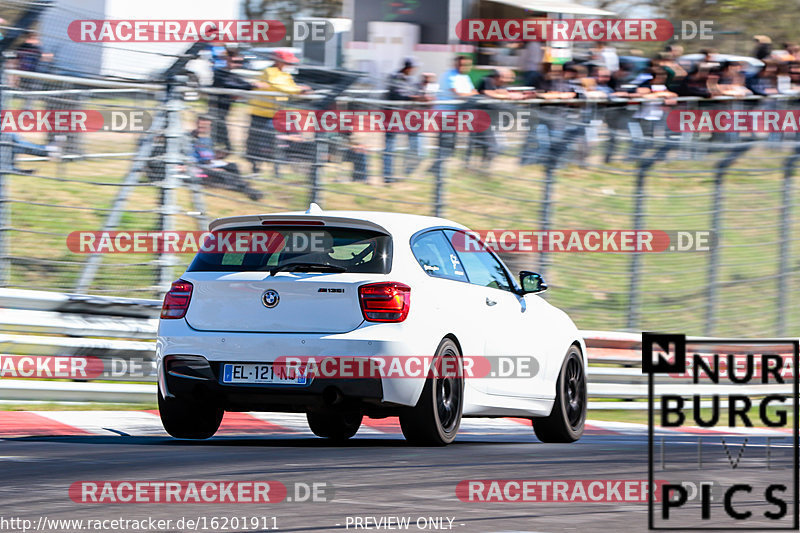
0, 412, 789, 532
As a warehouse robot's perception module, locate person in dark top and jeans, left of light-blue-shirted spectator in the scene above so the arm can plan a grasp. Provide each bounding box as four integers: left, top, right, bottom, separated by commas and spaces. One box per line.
383, 57, 432, 183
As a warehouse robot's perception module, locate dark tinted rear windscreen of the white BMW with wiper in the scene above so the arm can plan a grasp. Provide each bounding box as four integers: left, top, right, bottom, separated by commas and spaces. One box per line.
188, 226, 392, 274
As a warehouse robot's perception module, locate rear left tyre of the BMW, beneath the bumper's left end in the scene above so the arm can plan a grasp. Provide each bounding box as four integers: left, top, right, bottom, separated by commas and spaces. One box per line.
158, 391, 225, 440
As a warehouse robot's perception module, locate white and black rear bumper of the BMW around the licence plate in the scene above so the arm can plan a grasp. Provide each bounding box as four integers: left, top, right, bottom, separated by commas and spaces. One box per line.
156, 320, 436, 411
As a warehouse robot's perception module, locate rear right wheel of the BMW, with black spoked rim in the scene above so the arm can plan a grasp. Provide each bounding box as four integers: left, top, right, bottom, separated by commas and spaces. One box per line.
400, 339, 464, 446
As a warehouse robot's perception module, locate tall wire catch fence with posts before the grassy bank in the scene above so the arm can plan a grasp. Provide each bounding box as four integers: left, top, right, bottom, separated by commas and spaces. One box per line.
0, 68, 800, 336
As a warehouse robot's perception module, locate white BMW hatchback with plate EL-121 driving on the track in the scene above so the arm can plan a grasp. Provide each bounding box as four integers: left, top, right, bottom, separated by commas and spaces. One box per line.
157, 205, 587, 445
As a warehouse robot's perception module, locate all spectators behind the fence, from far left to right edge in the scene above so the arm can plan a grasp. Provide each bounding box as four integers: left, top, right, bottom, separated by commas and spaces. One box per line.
10, 28, 800, 189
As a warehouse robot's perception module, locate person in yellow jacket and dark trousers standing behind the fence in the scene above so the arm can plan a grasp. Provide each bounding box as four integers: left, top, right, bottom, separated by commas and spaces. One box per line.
246, 50, 311, 175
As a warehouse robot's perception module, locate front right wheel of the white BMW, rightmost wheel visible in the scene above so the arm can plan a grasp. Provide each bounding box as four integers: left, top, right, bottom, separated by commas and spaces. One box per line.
533, 346, 587, 442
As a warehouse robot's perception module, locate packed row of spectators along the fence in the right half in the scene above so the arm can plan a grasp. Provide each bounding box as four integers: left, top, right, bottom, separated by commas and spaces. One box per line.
370, 35, 800, 183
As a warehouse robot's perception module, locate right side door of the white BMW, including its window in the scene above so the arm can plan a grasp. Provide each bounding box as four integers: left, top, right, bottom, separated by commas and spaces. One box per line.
445, 230, 530, 396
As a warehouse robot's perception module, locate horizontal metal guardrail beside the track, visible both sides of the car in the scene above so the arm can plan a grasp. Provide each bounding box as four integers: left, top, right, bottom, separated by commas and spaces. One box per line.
0, 289, 791, 409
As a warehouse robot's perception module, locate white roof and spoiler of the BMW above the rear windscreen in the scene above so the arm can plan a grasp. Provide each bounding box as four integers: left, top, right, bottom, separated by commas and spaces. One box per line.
209, 206, 467, 236
